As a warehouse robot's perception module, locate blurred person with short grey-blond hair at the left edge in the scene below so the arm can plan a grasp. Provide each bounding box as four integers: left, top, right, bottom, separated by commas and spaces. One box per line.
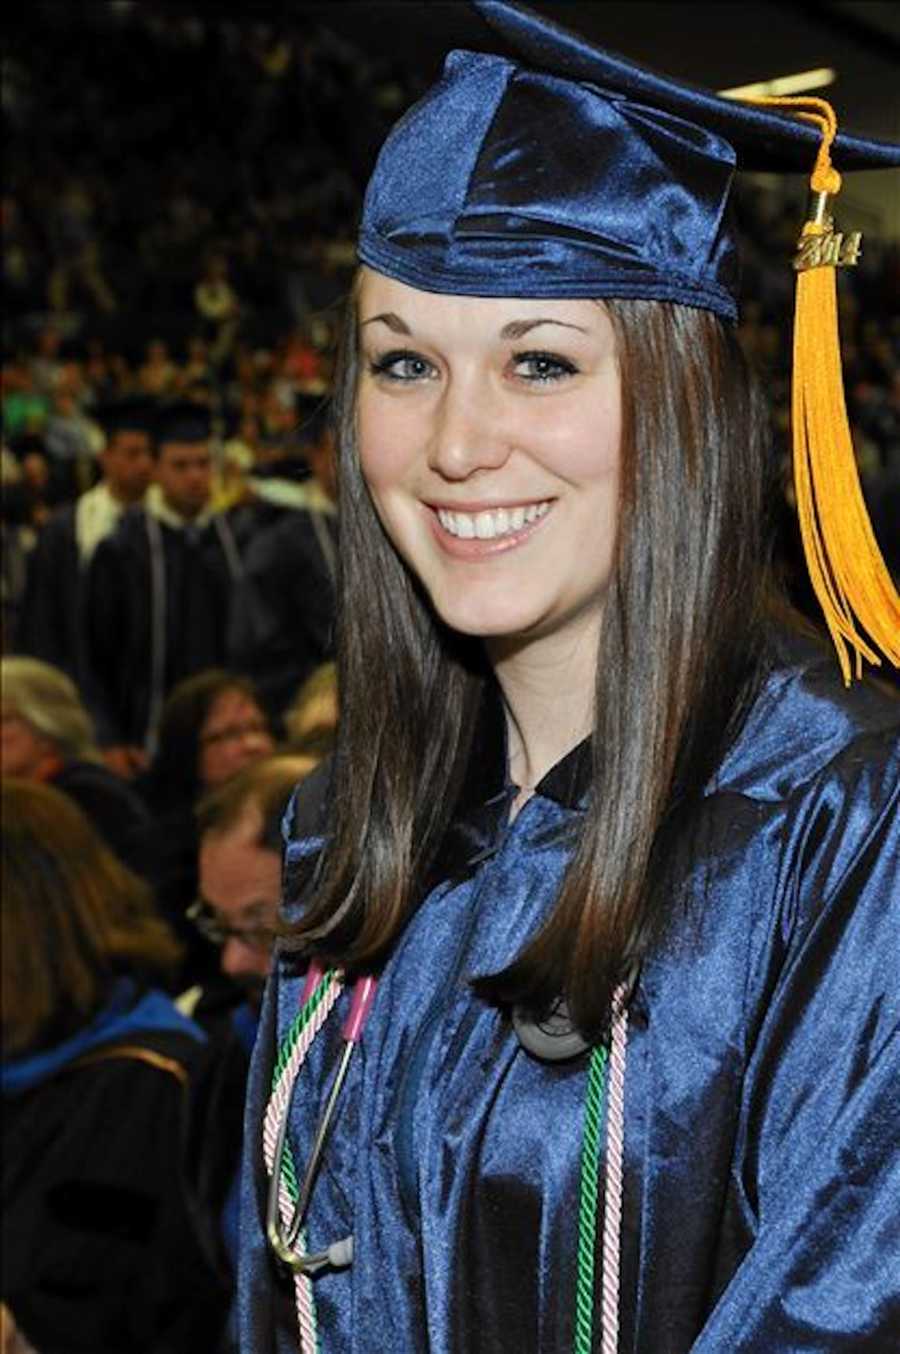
0, 657, 150, 875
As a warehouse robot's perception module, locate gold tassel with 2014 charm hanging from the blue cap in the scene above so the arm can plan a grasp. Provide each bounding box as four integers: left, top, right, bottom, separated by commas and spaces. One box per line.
747, 99, 900, 685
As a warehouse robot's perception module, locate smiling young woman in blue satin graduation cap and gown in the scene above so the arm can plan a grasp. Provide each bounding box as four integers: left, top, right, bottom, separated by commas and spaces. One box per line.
241, 5, 900, 1354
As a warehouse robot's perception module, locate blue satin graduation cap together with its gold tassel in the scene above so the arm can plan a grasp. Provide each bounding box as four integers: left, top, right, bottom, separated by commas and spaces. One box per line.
359, 0, 900, 681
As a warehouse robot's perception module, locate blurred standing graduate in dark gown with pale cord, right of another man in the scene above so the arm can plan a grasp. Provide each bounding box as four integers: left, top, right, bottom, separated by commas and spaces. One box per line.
85, 403, 241, 770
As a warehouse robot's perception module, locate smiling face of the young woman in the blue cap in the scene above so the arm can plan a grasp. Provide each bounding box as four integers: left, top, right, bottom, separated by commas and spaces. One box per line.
359, 269, 621, 640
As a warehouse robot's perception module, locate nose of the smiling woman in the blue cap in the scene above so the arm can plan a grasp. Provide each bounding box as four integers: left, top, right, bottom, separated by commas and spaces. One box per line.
428, 380, 512, 479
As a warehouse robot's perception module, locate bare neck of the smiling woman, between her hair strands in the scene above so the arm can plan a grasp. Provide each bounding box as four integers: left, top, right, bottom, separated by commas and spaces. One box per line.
487, 627, 597, 807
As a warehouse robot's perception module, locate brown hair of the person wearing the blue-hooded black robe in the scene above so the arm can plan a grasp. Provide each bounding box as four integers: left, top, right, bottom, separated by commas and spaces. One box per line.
0, 779, 181, 1056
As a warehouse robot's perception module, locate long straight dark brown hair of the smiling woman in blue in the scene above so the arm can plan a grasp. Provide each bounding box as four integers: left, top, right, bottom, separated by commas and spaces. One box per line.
285, 293, 767, 1037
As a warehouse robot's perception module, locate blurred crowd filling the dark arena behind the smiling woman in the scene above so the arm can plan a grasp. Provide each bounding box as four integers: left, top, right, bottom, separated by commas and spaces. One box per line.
0, 3, 900, 1354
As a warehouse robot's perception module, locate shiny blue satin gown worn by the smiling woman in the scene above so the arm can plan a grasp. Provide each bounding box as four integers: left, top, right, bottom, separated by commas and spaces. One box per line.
241, 636, 900, 1354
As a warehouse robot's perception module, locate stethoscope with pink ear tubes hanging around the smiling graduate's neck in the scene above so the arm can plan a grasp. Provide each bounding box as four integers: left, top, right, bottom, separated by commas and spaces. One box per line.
265, 961, 637, 1274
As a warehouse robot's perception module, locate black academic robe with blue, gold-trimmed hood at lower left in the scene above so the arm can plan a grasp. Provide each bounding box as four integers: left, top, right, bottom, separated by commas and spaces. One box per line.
3, 980, 229, 1354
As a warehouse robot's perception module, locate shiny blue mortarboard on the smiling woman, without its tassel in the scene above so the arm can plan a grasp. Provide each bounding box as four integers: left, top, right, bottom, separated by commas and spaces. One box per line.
359, 0, 900, 320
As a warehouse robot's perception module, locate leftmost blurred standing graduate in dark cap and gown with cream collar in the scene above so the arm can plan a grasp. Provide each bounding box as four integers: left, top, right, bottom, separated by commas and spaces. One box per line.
18, 401, 153, 684
